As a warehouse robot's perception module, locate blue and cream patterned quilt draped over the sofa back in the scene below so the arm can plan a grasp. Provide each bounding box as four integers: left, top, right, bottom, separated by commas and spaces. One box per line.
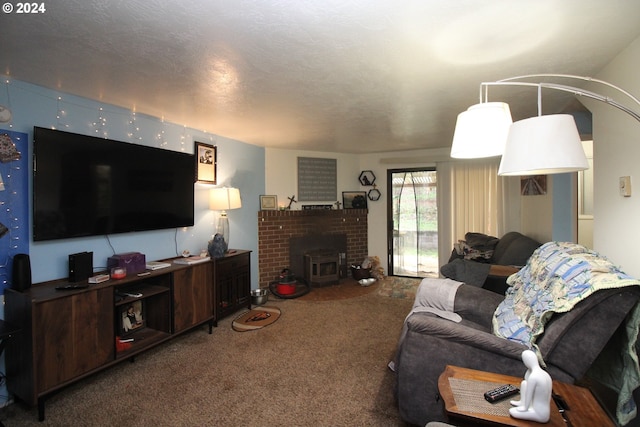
493, 242, 640, 425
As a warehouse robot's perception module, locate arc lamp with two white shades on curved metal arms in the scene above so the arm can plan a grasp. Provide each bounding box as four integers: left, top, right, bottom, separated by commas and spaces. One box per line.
451, 74, 640, 176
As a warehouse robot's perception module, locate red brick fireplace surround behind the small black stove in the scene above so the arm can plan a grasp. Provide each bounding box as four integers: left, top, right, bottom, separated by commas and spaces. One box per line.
258, 209, 368, 288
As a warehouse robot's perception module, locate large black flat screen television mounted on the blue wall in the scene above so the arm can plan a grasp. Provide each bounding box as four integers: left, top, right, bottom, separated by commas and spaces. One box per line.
33, 127, 195, 241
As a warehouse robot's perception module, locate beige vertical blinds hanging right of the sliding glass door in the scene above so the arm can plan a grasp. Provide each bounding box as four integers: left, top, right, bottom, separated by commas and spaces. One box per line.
436, 158, 519, 265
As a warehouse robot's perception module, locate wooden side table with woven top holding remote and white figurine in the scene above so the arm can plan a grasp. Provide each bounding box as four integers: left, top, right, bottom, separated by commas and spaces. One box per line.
438, 366, 614, 427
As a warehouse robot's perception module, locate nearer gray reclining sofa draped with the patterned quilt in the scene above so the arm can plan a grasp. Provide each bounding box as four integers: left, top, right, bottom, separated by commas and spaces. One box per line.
394, 245, 640, 426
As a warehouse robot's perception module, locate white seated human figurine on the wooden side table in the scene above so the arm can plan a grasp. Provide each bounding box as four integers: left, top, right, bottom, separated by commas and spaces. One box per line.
509, 350, 552, 423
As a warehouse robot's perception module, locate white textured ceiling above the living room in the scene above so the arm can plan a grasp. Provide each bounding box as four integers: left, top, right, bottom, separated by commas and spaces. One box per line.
0, 0, 640, 153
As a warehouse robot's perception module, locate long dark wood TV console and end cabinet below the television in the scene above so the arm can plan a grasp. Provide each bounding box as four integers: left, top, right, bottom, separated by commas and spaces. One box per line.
5, 250, 251, 421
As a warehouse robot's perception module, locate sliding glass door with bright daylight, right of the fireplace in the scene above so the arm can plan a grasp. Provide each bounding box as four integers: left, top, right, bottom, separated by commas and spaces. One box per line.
387, 169, 438, 277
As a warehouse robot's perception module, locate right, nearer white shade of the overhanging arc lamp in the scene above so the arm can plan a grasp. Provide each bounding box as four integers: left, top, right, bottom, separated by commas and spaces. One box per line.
498, 114, 589, 176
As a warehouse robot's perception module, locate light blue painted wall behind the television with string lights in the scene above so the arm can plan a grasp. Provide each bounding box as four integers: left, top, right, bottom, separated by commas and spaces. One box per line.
0, 80, 265, 288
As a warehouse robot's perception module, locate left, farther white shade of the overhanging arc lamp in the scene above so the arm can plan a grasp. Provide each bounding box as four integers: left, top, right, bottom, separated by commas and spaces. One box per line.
451, 102, 512, 159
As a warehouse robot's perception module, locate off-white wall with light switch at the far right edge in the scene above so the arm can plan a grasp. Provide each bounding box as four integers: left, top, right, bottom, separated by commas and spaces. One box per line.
584, 38, 640, 277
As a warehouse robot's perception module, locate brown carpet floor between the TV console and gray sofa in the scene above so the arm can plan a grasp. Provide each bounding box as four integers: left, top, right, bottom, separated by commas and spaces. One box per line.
0, 283, 413, 427
